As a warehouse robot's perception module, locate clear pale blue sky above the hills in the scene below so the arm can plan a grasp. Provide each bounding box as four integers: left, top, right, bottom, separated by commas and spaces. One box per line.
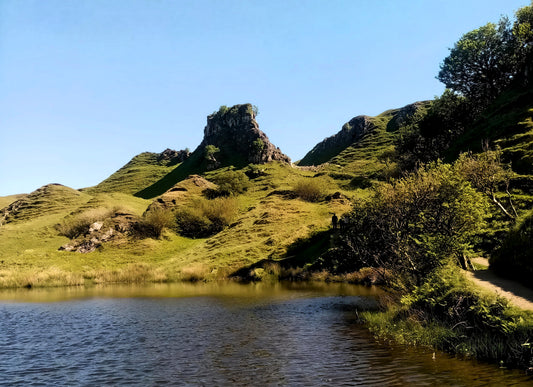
0, 0, 529, 196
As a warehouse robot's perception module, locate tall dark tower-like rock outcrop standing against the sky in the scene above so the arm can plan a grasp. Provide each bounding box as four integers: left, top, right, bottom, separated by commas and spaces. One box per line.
195, 104, 290, 169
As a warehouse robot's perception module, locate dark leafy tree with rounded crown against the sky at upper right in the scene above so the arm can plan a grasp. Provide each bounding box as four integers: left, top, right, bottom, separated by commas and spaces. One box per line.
437, 17, 516, 110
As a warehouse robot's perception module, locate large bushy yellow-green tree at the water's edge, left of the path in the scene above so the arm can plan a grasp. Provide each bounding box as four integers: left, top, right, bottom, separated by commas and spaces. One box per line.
334, 163, 486, 290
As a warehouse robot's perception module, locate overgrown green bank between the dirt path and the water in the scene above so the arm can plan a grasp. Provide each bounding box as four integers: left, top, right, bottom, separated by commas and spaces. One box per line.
362, 267, 533, 368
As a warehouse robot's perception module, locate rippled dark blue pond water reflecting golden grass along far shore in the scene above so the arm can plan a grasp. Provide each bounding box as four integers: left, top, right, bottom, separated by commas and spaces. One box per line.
0, 284, 533, 386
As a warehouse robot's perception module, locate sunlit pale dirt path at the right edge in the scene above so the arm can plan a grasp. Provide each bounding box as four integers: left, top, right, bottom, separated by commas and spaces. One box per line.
467, 258, 533, 310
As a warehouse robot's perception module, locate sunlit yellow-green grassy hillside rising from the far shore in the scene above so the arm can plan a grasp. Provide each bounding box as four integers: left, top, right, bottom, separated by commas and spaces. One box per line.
0, 163, 353, 288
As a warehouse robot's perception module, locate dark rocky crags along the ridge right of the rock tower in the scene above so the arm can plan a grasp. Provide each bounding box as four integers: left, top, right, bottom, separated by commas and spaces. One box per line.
298, 102, 427, 166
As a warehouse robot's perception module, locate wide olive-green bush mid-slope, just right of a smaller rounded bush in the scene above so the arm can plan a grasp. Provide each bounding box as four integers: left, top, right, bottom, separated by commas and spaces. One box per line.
176, 198, 238, 238
